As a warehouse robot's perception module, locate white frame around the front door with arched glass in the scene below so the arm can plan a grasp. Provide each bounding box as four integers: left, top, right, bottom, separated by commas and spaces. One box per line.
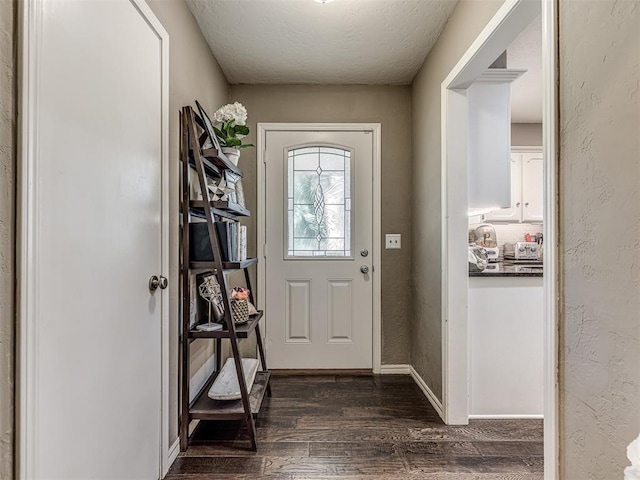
256, 123, 382, 373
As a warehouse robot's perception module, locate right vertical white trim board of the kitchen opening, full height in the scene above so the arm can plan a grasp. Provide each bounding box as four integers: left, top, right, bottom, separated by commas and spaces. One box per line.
542, 0, 560, 480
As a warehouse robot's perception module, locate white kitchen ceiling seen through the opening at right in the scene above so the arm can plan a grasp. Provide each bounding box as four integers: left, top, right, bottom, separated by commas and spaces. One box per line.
507, 17, 542, 123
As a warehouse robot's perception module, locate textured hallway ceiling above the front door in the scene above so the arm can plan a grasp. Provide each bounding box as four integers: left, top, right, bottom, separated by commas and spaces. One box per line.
187, 0, 457, 85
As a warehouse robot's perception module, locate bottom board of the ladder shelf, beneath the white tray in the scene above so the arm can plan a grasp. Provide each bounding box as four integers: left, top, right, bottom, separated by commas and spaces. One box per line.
189, 372, 271, 420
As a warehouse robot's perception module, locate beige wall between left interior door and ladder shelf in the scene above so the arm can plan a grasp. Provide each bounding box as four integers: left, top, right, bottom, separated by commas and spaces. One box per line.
147, 0, 229, 440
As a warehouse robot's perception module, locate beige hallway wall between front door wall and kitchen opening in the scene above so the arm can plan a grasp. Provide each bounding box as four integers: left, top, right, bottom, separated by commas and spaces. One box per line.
411, 0, 503, 398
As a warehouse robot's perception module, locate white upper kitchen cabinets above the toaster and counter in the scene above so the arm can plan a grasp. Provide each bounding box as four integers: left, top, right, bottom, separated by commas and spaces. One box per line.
482, 148, 544, 223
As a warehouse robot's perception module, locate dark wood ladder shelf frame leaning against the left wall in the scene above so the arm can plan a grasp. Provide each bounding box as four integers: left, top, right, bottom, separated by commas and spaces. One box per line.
180, 107, 271, 451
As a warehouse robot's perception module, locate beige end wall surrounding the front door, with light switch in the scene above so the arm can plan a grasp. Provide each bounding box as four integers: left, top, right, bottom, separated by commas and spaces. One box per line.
230, 85, 413, 364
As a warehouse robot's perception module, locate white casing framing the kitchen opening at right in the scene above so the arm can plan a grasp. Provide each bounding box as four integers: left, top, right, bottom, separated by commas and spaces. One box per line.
441, 0, 558, 480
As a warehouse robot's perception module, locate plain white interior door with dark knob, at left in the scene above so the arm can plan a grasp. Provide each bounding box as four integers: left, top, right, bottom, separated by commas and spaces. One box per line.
20, 0, 168, 479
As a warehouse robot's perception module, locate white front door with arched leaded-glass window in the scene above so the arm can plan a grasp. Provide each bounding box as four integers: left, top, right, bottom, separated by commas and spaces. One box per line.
265, 131, 374, 369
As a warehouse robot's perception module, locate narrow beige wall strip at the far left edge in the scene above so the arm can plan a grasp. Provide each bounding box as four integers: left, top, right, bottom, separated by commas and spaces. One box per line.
0, 1, 16, 480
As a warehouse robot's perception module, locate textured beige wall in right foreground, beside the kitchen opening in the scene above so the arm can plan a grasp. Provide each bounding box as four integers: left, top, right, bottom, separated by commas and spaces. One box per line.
559, 0, 640, 480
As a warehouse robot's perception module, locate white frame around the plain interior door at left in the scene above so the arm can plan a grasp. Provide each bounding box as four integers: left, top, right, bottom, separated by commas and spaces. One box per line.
16, 0, 172, 479
